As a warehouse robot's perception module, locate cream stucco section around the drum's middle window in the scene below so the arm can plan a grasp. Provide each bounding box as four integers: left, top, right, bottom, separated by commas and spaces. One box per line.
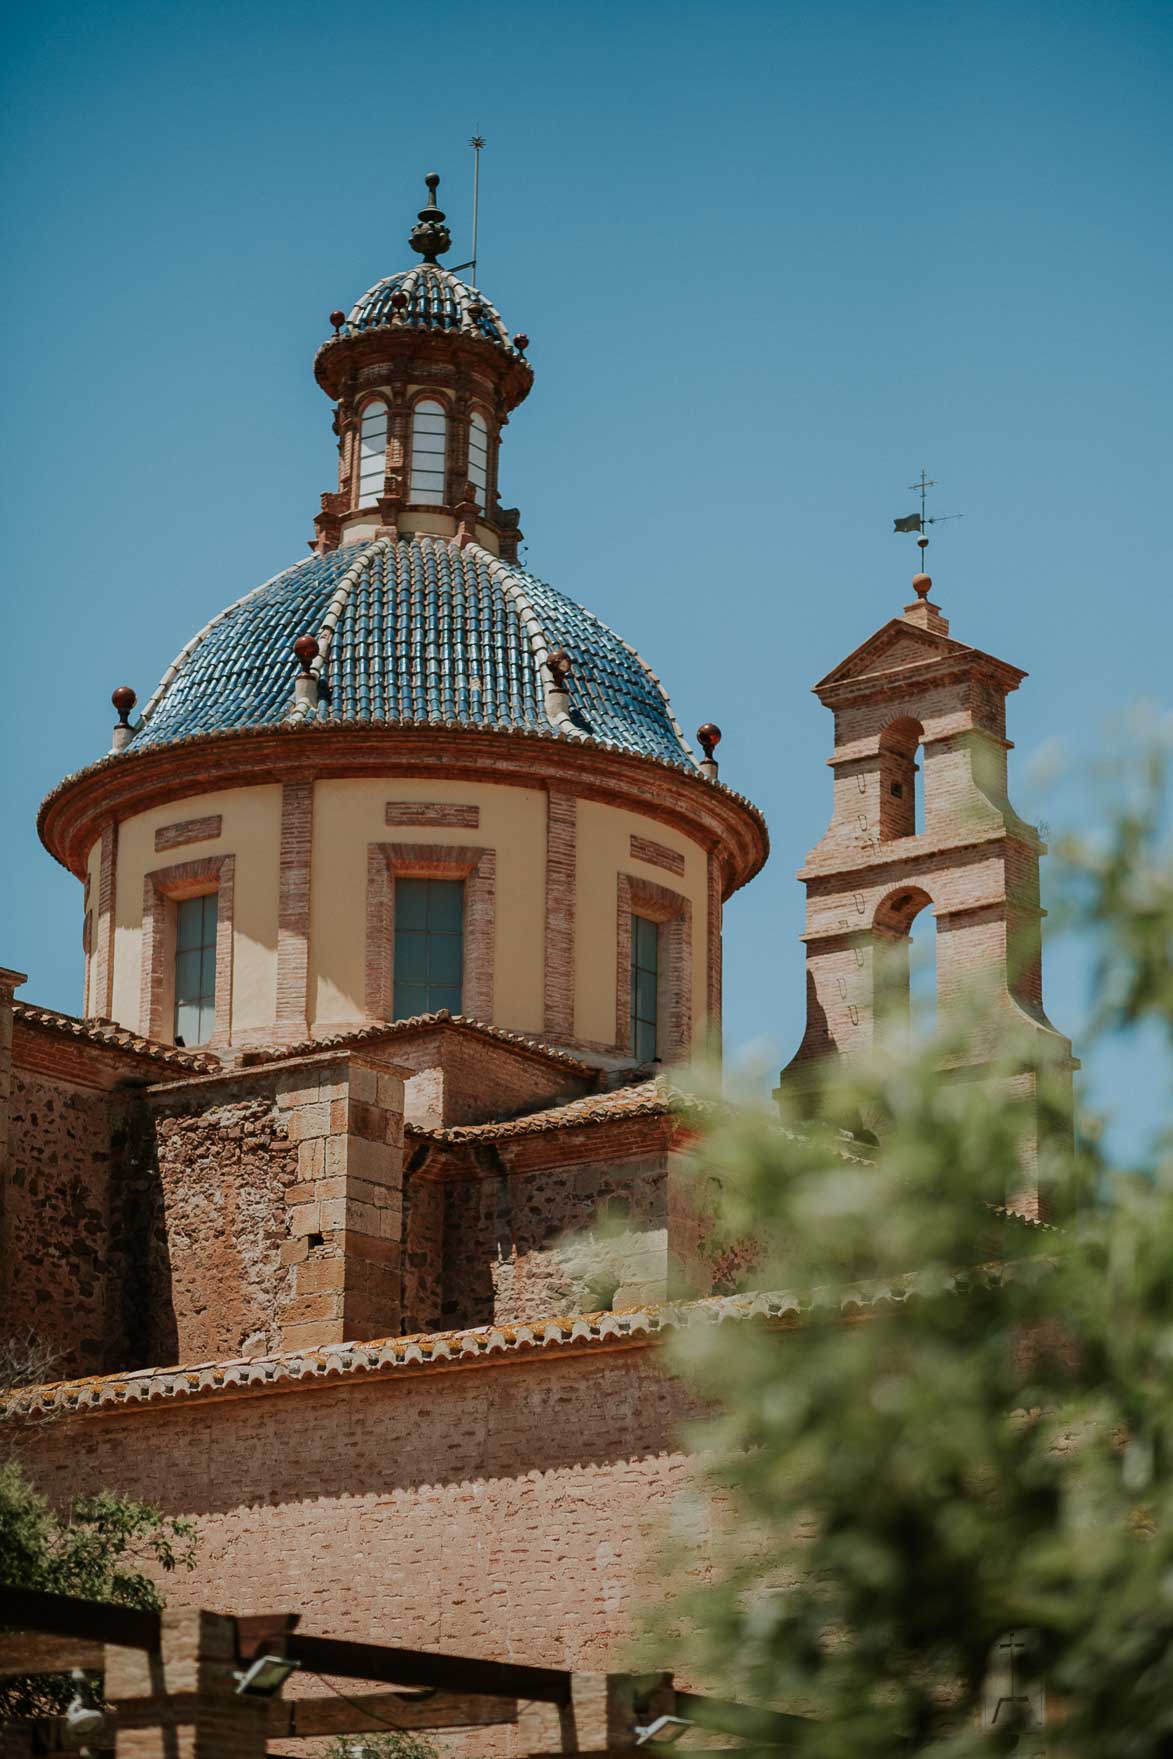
310, 781, 545, 1033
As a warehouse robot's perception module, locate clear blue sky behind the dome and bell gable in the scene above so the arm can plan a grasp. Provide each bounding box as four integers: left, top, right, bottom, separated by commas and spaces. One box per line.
0, 0, 1173, 1149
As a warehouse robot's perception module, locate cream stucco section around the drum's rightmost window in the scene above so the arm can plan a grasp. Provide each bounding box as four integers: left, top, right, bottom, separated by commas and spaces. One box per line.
575, 800, 709, 1045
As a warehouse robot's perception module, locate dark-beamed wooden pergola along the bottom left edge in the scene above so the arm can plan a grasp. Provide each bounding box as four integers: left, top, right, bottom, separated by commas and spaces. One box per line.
0, 1588, 804, 1759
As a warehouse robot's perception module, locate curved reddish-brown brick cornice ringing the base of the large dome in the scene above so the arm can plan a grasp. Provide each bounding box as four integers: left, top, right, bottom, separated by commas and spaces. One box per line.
37, 723, 770, 897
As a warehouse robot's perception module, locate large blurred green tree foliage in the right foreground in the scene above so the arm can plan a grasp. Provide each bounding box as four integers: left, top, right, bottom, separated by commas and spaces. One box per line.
658, 721, 1173, 1759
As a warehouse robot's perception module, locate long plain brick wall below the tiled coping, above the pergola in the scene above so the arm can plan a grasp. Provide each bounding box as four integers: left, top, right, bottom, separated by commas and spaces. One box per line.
16, 1346, 717, 1709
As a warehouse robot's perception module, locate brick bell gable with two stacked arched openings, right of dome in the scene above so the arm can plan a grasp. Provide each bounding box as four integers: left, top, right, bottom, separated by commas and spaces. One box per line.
783, 573, 1075, 1182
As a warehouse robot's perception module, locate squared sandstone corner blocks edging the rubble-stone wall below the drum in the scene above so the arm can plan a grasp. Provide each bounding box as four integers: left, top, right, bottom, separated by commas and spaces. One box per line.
278, 1054, 403, 1349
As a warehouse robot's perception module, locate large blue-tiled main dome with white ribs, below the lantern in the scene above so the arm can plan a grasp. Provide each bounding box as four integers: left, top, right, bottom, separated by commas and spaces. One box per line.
128, 535, 695, 769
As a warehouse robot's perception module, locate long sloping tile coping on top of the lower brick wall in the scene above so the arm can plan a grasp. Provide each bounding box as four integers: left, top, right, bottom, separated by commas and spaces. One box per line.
0, 1263, 1009, 1421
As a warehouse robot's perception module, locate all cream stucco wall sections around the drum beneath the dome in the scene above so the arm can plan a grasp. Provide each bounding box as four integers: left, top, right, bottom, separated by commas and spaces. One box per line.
90, 777, 709, 1047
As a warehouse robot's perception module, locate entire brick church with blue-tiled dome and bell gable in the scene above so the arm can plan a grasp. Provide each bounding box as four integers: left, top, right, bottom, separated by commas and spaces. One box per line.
0, 176, 1071, 1730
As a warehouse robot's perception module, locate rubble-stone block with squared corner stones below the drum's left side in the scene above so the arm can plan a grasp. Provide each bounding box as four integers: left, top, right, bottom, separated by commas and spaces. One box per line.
149, 1052, 403, 1363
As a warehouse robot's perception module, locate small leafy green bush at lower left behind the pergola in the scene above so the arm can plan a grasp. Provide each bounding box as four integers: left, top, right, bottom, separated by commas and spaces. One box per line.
0, 1460, 195, 1720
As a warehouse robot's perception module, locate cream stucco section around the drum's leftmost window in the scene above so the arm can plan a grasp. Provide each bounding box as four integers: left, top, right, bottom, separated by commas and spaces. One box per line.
110, 785, 281, 1036
